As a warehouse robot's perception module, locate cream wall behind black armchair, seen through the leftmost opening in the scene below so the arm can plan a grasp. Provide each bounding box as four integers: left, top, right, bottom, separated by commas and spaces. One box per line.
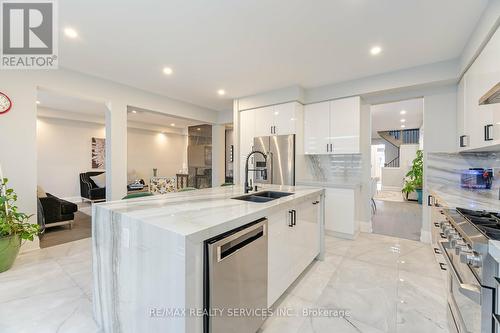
37, 117, 106, 200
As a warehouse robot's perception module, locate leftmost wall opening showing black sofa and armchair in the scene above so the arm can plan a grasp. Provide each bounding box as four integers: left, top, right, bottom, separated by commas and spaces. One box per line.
36, 88, 109, 248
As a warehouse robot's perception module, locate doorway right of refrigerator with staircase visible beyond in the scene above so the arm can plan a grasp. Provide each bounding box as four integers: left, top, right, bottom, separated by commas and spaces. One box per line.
370, 98, 424, 241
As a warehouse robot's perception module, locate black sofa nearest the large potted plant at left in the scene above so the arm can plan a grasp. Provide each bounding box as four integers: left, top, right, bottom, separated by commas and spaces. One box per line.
38, 193, 78, 229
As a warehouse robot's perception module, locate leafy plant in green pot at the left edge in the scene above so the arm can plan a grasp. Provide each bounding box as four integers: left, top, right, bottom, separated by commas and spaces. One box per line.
0, 178, 39, 273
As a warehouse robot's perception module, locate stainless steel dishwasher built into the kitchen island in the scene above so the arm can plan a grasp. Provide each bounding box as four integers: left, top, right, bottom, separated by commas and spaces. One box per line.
203, 218, 267, 333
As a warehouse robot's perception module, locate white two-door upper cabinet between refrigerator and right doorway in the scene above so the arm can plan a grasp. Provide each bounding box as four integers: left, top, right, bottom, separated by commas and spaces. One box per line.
304, 97, 361, 154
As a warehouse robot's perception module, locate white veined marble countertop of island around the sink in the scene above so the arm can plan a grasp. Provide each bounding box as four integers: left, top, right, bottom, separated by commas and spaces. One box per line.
93, 185, 324, 241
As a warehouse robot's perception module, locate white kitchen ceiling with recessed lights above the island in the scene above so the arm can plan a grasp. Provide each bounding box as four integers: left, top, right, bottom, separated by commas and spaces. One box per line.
59, 0, 488, 110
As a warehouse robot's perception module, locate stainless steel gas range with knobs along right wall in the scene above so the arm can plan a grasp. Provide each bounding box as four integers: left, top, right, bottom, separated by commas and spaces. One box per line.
439, 208, 500, 333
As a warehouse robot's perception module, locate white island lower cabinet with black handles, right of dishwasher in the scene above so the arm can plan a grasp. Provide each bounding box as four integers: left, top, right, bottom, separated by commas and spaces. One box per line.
267, 196, 320, 307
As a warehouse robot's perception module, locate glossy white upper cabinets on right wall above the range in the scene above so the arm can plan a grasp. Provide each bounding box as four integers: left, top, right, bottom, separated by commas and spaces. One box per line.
457, 29, 500, 151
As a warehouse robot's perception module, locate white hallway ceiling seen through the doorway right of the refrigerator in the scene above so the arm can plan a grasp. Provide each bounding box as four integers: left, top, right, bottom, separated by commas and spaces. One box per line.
371, 98, 424, 138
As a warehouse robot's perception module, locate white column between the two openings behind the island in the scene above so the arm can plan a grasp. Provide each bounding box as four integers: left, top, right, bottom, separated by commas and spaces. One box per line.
106, 102, 127, 201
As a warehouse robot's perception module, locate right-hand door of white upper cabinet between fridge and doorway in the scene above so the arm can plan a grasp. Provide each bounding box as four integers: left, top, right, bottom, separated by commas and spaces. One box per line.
330, 97, 361, 154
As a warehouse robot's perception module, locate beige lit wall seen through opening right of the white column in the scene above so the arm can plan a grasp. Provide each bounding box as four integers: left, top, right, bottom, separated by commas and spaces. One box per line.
127, 128, 187, 184
